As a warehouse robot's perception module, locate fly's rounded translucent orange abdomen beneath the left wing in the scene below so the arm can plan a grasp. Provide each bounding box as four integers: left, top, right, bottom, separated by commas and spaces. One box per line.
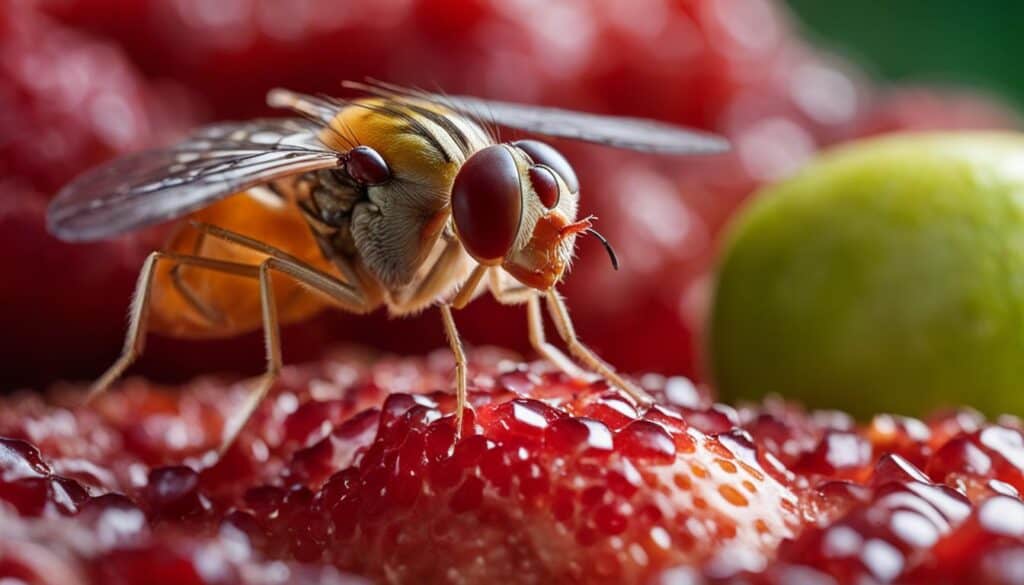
150, 193, 337, 338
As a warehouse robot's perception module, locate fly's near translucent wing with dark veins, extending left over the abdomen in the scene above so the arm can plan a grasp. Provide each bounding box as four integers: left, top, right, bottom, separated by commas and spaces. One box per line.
47, 119, 339, 241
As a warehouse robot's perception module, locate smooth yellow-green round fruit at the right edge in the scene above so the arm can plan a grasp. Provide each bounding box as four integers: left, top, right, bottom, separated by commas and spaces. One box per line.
709, 133, 1024, 417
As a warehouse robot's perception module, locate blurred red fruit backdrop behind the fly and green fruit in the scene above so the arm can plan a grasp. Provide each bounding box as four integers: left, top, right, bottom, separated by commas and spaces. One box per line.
0, 0, 1016, 388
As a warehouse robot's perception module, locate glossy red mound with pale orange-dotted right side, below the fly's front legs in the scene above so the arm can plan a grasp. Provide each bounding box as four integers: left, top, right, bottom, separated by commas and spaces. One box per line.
313, 388, 794, 581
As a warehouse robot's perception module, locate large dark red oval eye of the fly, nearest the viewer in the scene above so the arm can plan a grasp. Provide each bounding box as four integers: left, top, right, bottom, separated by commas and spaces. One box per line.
452, 145, 522, 262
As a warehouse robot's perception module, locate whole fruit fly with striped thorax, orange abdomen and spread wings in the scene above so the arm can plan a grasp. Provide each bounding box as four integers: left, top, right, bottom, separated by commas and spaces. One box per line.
47, 82, 727, 452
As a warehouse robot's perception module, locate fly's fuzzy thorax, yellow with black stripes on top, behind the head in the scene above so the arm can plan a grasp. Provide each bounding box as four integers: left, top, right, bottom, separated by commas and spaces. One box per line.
311, 98, 489, 292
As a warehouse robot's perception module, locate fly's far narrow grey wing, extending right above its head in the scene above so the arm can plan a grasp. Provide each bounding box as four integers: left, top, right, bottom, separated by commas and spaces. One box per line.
346, 82, 729, 155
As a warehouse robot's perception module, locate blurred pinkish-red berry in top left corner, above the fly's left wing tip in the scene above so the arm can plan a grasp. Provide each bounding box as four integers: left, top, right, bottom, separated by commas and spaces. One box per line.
0, 3, 188, 193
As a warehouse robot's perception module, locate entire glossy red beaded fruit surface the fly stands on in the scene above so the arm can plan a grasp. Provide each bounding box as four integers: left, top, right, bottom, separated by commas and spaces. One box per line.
6, 349, 1024, 583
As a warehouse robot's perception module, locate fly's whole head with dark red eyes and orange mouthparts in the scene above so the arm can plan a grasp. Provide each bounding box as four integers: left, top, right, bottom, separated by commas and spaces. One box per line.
452, 140, 590, 290
